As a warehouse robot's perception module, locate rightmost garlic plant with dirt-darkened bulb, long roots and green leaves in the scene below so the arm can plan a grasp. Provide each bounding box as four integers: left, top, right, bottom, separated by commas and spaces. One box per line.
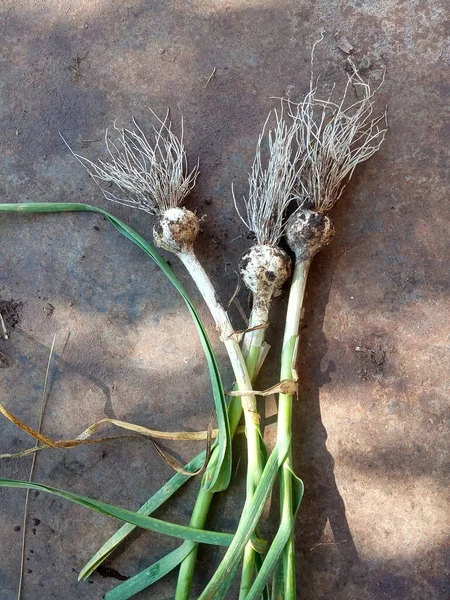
200, 48, 386, 600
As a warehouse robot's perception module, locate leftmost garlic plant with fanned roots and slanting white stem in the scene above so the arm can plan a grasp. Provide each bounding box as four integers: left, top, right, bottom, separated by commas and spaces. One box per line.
65, 110, 272, 598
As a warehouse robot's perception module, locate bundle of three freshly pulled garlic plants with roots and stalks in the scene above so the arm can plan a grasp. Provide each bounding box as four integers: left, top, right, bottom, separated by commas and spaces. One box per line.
66, 43, 386, 600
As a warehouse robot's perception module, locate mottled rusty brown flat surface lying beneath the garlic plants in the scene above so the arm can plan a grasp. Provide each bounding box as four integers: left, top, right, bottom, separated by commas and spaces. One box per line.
0, 0, 450, 600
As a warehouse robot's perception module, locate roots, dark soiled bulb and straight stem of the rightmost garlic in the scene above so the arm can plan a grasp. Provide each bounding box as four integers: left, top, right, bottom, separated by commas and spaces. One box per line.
268, 48, 387, 600
